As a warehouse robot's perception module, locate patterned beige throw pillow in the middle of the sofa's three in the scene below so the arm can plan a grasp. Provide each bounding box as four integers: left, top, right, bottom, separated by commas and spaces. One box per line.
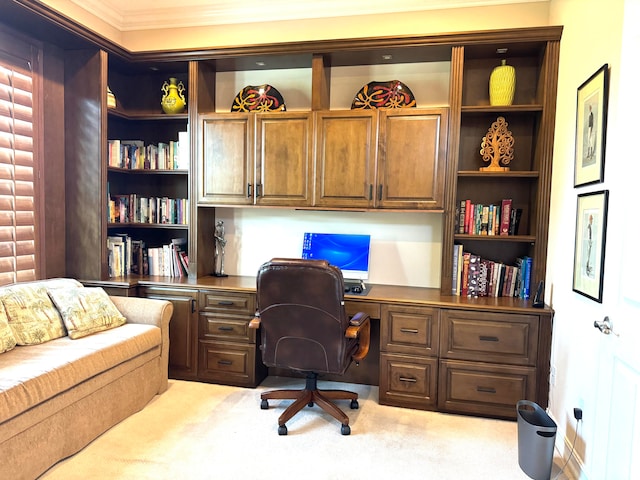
2, 285, 67, 345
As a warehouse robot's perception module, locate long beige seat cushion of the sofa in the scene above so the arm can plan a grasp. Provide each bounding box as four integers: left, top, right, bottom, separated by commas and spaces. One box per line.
0, 323, 162, 424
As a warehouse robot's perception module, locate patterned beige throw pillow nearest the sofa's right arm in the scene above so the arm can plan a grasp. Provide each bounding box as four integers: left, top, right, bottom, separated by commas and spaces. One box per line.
49, 287, 127, 339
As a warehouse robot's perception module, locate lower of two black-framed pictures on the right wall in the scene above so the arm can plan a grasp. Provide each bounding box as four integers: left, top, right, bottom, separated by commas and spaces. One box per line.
573, 190, 609, 303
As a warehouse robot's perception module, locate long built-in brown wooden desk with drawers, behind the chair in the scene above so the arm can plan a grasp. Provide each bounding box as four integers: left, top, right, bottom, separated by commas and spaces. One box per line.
84, 276, 553, 418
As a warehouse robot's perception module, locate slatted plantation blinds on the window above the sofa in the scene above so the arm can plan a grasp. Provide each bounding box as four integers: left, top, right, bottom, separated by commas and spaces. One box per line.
0, 51, 36, 285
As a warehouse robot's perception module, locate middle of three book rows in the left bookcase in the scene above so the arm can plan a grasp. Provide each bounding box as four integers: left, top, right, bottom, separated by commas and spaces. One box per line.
109, 193, 189, 225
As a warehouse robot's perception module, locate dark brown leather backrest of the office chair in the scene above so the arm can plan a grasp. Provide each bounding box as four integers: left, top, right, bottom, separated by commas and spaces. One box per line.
257, 258, 357, 374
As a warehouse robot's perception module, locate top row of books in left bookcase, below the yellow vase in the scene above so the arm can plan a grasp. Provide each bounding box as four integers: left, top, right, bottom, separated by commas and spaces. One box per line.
108, 132, 189, 170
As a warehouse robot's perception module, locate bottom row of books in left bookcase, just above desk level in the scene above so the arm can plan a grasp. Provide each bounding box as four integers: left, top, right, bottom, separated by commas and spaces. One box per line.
107, 233, 189, 277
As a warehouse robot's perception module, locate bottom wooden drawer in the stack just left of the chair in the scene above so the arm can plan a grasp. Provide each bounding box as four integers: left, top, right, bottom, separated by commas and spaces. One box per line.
198, 341, 256, 386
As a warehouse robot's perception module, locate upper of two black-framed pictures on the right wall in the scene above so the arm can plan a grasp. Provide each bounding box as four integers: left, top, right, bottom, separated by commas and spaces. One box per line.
573, 63, 609, 187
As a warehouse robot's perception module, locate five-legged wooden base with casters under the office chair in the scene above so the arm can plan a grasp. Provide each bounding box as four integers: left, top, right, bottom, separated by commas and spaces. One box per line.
260, 373, 359, 435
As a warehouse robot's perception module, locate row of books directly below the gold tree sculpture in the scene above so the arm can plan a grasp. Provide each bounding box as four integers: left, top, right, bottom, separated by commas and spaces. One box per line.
456, 198, 522, 235
